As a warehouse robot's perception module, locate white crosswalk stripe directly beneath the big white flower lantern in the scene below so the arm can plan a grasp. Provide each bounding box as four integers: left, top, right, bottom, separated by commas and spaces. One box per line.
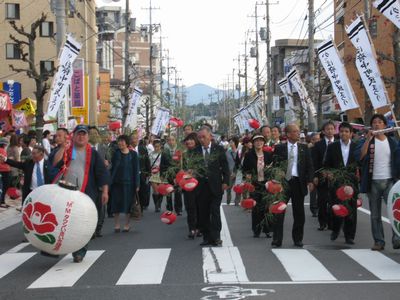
28, 250, 104, 289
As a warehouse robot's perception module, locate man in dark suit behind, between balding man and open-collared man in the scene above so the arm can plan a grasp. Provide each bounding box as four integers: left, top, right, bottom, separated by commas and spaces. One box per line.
312, 121, 335, 231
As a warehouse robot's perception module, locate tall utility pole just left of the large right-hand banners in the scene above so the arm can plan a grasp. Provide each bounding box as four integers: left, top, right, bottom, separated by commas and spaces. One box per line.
308, 0, 315, 130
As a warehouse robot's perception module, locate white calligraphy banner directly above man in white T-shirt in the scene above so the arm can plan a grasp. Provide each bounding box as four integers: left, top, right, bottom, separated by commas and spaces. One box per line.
346, 17, 390, 109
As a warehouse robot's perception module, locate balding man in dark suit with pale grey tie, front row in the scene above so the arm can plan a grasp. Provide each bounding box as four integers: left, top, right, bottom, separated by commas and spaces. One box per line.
271, 124, 314, 248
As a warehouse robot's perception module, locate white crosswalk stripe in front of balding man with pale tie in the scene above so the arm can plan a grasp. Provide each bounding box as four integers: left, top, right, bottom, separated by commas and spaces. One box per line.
272, 249, 337, 281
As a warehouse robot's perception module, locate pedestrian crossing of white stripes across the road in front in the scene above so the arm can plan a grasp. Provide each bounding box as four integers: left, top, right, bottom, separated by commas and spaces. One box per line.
0, 245, 400, 289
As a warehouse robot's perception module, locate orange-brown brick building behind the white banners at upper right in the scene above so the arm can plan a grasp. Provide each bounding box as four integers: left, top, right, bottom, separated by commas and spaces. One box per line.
334, 0, 395, 123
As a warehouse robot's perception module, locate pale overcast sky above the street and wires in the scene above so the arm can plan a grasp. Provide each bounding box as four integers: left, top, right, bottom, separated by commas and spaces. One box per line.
96, 0, 333, 88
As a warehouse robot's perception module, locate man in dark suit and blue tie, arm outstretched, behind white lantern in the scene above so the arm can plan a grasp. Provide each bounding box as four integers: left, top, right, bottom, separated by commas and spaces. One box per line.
0, 146, 55, 204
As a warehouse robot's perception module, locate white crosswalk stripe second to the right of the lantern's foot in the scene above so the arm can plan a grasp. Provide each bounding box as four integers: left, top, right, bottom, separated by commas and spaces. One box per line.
117, 249, 171, 285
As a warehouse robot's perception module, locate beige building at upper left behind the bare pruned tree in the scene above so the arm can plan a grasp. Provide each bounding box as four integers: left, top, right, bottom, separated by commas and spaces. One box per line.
0, 0, 98, 124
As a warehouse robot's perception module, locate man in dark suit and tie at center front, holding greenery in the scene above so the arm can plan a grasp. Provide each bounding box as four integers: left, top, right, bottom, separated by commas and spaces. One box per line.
195, 126, 229, 246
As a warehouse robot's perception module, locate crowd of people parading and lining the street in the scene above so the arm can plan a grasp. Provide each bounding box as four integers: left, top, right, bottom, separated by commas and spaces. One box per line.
0, 114, 400, 262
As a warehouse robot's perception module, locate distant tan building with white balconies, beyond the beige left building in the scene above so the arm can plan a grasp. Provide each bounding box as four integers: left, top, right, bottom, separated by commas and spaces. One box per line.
96, 6, 162, 129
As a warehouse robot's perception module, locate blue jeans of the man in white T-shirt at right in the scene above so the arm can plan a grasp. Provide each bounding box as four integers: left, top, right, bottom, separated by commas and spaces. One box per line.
368, 179, 400, 246
